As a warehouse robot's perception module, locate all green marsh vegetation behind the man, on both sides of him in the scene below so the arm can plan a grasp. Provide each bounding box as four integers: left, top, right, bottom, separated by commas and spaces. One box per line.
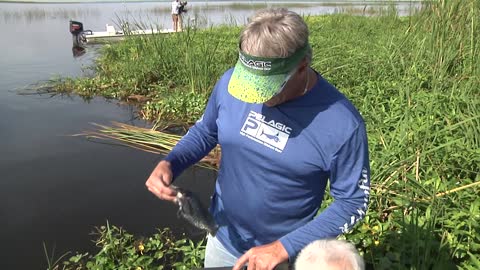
49, 0, 480, 269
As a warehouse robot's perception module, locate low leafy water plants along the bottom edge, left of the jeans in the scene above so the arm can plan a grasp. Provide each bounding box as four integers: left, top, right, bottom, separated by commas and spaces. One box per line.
47, 222, 205, 270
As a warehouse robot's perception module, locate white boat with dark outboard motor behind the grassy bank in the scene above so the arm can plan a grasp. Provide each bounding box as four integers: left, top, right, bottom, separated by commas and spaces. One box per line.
70, 20, 175, 47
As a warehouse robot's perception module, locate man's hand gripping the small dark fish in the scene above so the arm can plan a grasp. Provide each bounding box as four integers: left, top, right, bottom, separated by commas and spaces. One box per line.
145, 160, 177, 202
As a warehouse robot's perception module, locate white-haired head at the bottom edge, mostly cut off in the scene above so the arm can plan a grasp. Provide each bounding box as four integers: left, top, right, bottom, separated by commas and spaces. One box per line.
295, 239, 365, 270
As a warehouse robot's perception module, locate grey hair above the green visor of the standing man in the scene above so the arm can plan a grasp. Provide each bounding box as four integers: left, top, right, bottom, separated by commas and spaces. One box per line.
240, 8, 312, 62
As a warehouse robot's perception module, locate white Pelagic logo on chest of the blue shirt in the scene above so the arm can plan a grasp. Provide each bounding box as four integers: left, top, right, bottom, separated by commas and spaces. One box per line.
240, 111, 292, 153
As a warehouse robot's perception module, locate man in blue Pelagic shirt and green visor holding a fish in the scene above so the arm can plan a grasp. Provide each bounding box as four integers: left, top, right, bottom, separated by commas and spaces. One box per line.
146, 9, 370, 270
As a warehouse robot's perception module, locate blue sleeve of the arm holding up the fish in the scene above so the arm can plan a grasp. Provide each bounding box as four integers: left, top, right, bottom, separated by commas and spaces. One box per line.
164, 80, 219, 179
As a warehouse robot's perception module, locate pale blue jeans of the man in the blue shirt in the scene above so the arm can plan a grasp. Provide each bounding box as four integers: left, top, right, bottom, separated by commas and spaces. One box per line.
204, 234, 238, 268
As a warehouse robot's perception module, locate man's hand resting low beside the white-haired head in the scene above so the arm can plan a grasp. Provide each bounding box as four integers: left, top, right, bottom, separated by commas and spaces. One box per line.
233, 240, 288, 270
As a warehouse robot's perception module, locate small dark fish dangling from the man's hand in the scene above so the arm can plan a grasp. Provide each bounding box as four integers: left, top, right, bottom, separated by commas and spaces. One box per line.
170, 185, 218, 236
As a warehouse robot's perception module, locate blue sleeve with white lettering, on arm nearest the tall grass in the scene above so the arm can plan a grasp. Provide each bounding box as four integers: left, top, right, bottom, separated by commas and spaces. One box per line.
280, 122, 370, 260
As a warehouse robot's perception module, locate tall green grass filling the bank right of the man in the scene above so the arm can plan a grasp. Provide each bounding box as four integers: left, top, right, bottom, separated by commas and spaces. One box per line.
315, 1, 480, 269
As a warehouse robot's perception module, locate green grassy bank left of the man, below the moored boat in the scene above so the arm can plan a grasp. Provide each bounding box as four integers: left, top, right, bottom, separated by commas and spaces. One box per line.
55, 23, 239, 122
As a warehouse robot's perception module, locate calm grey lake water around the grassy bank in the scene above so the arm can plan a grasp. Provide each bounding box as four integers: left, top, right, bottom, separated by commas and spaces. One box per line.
0, 1, 418, 269
